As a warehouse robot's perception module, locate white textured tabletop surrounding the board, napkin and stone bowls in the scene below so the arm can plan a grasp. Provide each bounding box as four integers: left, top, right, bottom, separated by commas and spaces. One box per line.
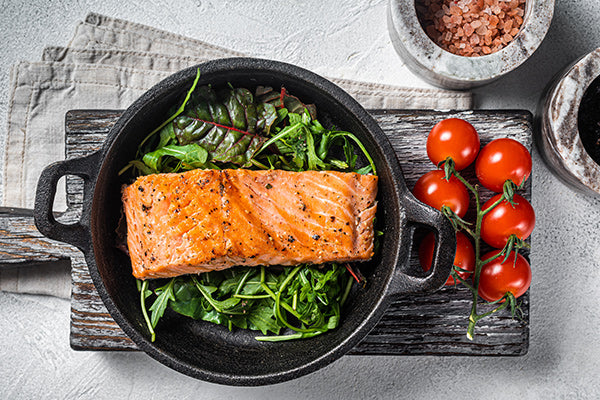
0, 0, 600, 399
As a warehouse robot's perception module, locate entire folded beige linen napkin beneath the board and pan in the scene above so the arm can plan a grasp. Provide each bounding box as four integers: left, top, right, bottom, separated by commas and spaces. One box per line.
0, 13, 472, 297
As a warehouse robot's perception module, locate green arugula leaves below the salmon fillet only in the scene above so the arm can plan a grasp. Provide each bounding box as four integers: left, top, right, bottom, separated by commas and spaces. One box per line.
144, 263, 352, 341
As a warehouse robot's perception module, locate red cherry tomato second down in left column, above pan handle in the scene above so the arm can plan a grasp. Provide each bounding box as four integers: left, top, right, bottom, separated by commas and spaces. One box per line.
413, 169, 469, 218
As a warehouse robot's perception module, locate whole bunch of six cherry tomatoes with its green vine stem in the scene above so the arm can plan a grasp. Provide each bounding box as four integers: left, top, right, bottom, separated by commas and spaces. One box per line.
413, 118, 535, 340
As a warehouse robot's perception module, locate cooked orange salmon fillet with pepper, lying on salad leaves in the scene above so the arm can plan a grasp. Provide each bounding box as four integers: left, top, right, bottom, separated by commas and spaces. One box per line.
122, 169, 377, 279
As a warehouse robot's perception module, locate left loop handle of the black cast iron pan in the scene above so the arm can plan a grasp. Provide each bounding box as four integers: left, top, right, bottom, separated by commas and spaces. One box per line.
34, 151, 100, 253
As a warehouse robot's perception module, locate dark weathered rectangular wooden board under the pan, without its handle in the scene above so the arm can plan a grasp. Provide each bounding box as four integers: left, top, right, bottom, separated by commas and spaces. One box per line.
15, 110, 535, 356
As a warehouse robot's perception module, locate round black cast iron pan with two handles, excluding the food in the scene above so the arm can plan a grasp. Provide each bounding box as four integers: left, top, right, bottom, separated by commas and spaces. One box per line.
35, 58, 455, 385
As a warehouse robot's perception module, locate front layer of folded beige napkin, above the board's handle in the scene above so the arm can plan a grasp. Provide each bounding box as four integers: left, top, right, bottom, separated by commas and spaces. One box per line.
3, 62, 169, 211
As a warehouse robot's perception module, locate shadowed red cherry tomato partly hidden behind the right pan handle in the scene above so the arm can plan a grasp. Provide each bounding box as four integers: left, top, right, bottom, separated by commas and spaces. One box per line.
419, 232, 475, 286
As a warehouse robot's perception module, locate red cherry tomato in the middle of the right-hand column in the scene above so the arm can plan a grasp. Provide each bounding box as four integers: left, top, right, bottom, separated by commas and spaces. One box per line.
481, 194, 535, 249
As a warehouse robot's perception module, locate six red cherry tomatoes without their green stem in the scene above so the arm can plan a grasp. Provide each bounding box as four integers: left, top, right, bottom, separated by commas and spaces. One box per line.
413, 118, 535, 301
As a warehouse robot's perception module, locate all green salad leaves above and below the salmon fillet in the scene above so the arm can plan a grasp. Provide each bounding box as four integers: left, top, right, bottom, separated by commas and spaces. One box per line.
126, 71, 376, 341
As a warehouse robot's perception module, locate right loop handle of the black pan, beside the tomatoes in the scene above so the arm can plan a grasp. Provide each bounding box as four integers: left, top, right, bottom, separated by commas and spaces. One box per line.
392, 191, 456, 296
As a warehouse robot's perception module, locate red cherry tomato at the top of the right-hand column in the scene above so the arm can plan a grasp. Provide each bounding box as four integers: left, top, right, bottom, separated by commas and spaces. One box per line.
475, 138, 531, 193
